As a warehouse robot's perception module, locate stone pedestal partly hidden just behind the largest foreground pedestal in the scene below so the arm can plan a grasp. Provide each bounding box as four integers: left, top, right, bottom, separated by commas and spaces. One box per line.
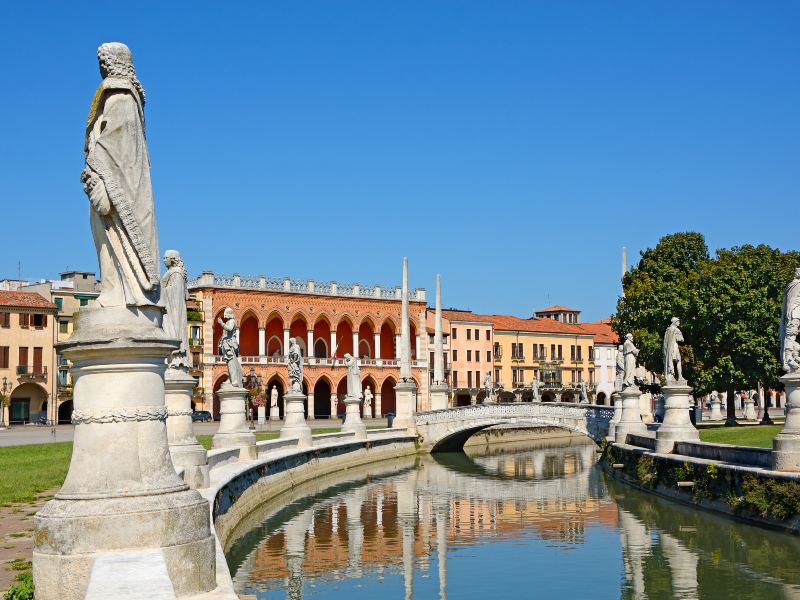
164, 369, 209, 489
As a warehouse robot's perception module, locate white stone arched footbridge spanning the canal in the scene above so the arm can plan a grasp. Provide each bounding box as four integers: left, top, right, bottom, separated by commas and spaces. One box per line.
414, 402, 614, 452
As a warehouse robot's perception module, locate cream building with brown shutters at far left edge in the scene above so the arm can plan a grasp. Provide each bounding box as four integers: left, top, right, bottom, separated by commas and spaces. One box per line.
0, 291, 58, 424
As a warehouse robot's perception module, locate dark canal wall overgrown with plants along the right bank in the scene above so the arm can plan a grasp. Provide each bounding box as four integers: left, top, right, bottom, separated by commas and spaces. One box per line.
601, 436, 800, 534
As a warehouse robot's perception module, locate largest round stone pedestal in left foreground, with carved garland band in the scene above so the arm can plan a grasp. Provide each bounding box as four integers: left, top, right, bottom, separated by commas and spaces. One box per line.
33, 307, 216, 600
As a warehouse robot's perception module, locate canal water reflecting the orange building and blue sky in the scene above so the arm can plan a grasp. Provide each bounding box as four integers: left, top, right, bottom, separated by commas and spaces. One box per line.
226, 438, 800, 600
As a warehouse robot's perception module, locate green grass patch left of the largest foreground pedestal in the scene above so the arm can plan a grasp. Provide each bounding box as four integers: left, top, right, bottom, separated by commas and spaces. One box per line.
0, 442, 72, 506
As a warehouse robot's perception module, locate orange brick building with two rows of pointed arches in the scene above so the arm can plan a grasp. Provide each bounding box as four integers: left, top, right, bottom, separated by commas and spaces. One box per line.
189, 272, 428, 418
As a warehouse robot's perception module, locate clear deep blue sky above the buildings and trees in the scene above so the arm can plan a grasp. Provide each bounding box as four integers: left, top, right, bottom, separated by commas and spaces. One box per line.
0, 0, 800, 319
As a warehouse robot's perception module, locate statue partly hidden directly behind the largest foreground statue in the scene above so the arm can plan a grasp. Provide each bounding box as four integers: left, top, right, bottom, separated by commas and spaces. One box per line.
161, 250, 192, 370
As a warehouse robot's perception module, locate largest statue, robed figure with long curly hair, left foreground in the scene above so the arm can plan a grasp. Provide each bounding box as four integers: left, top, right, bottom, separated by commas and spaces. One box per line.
81, 42, 160, 307
